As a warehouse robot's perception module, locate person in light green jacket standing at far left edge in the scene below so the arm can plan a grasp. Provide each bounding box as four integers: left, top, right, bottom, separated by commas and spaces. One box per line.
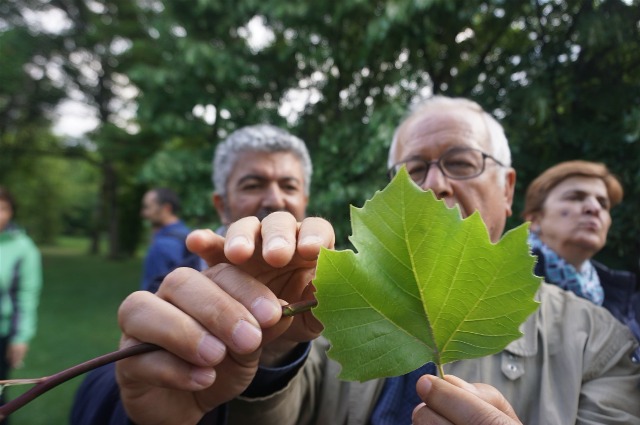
0, 187, 42, 402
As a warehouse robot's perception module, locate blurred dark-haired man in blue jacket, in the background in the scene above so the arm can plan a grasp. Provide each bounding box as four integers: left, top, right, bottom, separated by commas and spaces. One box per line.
140, 187, 192, 292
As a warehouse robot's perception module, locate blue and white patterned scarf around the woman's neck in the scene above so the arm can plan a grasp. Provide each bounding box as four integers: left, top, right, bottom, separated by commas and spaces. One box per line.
529, 232, 604, 305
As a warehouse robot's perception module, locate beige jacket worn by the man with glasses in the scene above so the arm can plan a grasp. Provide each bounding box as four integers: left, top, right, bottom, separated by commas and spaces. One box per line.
229, 284, 640, 425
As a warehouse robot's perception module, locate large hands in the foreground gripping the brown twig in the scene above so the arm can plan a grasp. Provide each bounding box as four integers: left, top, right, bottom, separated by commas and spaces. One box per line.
116, 213, 334, 425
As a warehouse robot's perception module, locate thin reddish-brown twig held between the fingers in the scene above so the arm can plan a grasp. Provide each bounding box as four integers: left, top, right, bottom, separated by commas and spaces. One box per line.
0, 300, 317, 420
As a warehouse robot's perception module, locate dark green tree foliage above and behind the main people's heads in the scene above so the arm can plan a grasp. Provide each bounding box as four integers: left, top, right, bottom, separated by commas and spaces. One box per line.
121, 0, 640, 265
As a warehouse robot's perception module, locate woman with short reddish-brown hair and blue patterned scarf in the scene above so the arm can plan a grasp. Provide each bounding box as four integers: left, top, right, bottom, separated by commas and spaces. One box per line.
522, 160, 640, 356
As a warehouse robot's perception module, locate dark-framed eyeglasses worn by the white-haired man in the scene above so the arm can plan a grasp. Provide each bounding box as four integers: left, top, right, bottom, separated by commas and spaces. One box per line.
389, 148, 505, 185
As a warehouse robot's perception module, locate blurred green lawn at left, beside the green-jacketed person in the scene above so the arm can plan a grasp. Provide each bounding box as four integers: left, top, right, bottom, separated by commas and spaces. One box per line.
6, 239, 142, 425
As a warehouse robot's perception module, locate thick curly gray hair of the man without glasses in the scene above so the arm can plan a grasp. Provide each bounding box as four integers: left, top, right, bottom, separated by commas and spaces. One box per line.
211, 124, 313, 196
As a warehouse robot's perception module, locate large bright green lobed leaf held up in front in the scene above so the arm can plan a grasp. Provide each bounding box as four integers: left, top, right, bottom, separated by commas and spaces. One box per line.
313, 169, 541, 381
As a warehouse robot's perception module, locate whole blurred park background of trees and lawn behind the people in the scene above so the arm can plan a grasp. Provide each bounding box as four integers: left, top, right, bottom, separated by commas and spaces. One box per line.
0, 0, 640, 424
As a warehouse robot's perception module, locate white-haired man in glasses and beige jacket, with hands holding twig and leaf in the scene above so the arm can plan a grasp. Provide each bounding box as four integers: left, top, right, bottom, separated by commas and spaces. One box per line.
71, 97, 640, 425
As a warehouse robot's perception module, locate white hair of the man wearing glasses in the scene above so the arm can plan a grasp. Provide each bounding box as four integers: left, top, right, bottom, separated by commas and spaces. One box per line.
387, 95, 511, 184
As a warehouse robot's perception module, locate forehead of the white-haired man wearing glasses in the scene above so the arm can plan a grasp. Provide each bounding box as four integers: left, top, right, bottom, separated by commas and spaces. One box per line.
392, 109, 493, 161
